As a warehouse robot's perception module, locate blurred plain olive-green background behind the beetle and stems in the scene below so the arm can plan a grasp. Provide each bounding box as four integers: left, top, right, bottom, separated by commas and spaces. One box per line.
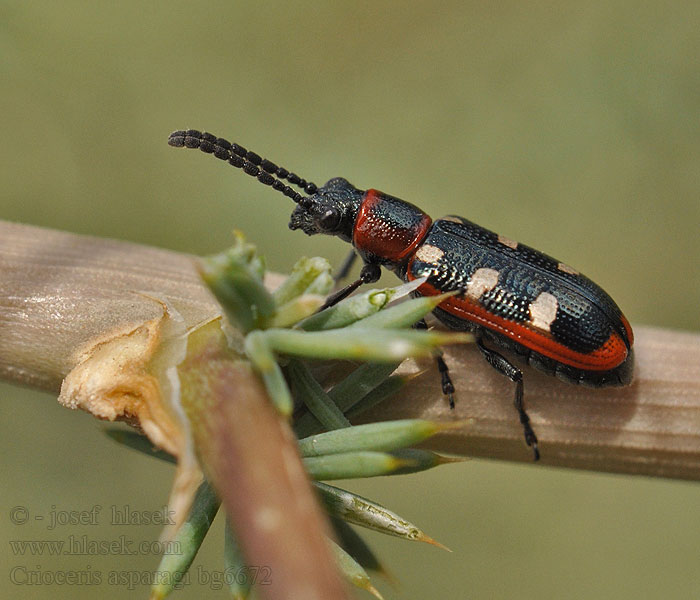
0, 0, 700, 599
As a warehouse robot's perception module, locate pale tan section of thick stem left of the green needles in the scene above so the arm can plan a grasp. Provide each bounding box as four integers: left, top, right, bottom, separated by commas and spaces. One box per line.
0, 221, 219, 393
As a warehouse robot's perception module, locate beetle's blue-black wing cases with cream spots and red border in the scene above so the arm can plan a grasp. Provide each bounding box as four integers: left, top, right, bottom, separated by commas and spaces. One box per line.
405, 217, 632, 385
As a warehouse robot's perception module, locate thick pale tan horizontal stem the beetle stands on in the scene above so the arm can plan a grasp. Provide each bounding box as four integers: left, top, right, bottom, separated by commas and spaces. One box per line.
0, 222, 700, 479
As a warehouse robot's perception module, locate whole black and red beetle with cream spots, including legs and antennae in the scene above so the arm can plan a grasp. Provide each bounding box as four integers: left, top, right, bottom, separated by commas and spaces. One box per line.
168, 129, 634, 460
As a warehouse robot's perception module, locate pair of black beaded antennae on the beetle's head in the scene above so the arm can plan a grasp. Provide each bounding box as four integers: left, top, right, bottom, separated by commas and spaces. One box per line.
168, 129, 318, 204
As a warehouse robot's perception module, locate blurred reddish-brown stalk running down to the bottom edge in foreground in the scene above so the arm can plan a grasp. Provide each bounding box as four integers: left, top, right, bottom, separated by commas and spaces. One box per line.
178, 323, 348, 600
